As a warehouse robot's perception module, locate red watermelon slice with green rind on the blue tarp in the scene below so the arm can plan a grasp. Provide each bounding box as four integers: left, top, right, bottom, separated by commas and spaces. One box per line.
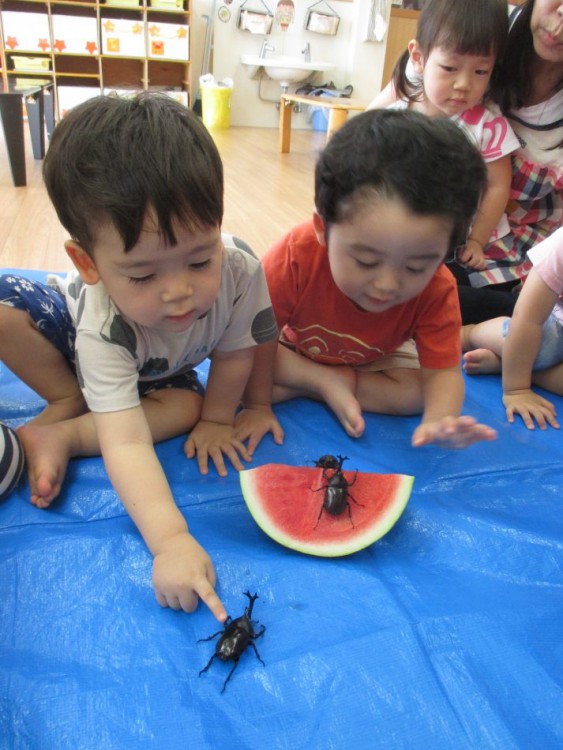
240, 464, 414, 557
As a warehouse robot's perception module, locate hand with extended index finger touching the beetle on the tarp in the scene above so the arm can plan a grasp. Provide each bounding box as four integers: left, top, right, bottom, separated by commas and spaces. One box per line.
152, 533, 227, 622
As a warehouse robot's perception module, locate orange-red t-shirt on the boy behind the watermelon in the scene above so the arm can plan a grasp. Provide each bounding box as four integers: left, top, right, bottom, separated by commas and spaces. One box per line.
262, 221, 461, 369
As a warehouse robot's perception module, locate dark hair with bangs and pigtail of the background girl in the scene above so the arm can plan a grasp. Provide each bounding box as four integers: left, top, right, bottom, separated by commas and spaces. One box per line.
393, 0, 508, 100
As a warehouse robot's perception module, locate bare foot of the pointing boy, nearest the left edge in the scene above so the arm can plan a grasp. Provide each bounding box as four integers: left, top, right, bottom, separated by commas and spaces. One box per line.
18, 423, 75, 508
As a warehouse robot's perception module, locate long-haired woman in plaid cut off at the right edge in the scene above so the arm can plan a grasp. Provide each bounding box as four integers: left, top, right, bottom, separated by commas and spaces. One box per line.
370, 0, 563, 323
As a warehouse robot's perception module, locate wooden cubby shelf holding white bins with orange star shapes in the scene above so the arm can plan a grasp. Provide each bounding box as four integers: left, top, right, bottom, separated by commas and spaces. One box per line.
0, 0, 191, 118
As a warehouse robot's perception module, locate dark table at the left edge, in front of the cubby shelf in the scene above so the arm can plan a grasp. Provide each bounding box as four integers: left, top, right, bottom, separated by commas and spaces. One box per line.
0, 78, 55, 187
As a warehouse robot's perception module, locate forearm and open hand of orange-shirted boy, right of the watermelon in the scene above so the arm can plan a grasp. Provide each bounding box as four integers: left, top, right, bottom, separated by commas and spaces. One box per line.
412, 366, 496, 448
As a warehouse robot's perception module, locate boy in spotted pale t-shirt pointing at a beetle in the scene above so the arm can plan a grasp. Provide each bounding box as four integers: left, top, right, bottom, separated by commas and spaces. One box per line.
0, 95, 281, 620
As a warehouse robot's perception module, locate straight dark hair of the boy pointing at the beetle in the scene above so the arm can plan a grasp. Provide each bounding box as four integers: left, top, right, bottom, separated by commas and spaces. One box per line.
43, 94, 223, 254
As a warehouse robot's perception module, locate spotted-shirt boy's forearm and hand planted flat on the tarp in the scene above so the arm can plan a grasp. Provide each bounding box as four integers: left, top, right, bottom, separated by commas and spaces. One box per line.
184, 346, 256, 477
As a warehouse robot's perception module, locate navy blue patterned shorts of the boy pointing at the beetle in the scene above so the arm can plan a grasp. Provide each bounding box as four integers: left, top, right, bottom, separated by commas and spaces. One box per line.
0, 274, 204, 396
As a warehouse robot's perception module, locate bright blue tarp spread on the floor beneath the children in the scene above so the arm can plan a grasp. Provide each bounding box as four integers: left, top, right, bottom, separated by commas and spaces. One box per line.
0, 270, 563, 750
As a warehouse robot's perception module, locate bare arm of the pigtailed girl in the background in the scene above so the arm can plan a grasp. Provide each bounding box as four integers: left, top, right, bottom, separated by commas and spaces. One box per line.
457, 154, 512, 271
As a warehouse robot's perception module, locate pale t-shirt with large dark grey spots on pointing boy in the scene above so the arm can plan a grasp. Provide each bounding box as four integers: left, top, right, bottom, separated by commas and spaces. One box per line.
49, 234, 277, 412
